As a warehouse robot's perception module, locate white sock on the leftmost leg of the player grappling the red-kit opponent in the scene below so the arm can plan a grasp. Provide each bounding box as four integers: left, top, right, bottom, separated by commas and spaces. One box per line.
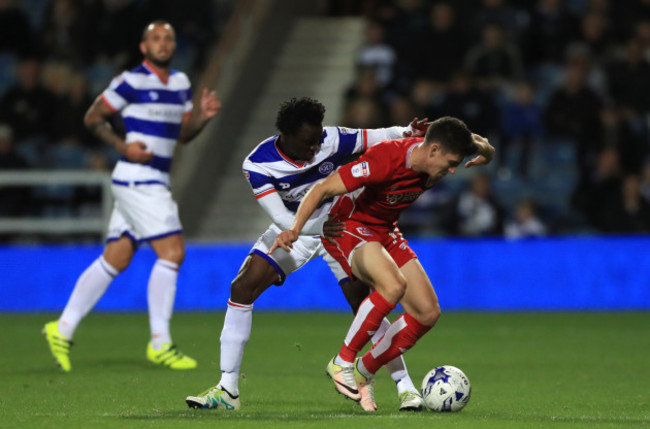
219, 300, 253, 396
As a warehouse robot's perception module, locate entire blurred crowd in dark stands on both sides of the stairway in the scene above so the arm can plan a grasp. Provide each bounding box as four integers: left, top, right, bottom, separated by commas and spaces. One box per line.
0, 0, 650, 238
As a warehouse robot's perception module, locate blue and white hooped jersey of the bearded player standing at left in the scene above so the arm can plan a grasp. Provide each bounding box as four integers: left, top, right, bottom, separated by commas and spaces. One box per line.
101, 61, 192, 185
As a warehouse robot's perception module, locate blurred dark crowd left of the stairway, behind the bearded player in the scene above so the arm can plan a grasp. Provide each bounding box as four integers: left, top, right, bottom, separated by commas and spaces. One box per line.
0, 0, 232, 221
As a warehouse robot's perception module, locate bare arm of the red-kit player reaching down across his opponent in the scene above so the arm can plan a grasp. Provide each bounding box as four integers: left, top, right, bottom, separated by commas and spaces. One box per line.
268, 171, 348, 254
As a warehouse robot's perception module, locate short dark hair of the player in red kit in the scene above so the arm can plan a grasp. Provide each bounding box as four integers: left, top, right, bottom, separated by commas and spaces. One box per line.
424, 116, 478, 158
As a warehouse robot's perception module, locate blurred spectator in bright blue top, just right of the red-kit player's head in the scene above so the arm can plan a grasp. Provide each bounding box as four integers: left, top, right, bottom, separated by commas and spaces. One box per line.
497, 81, 544, 179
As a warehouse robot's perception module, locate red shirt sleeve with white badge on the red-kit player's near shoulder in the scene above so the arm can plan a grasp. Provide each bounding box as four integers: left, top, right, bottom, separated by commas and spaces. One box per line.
339, 142, 392, 192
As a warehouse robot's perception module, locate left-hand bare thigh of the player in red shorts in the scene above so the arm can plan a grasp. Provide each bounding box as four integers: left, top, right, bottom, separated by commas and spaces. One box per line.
351, 241, 406, 304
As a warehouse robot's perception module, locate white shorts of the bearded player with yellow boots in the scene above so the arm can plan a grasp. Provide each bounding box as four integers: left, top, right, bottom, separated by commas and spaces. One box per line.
106, 184, 183, 243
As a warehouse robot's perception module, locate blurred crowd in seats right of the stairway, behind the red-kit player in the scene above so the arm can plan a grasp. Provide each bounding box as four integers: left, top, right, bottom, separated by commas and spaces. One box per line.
326, 0, 650, 238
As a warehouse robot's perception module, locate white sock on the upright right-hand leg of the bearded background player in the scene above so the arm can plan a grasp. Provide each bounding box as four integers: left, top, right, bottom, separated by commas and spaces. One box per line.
147, 259, 178, 350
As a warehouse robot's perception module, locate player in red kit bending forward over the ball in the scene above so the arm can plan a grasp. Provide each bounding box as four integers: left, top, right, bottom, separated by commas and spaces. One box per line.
271, 117, 494, 410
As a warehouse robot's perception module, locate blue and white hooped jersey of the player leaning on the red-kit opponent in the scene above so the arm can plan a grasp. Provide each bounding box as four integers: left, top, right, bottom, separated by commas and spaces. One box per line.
242, 127, 368, 224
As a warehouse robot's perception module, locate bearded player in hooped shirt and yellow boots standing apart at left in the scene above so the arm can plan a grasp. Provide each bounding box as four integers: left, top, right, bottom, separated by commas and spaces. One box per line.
44, 21, 221, 371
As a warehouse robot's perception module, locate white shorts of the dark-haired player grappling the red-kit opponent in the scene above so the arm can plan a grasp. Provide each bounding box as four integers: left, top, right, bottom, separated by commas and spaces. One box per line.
250, 224, 348, 285
